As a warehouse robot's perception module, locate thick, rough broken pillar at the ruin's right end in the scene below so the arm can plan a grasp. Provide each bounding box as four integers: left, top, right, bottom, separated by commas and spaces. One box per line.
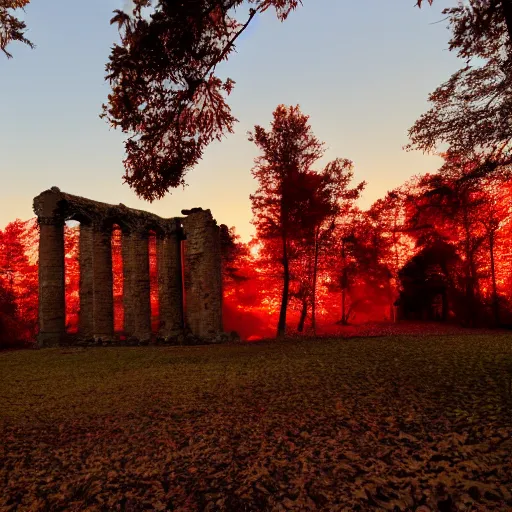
182, 210, 223, 338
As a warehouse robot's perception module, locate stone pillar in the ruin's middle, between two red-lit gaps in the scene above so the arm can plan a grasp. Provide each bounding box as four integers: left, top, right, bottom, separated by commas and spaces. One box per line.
123, 232, 151, 341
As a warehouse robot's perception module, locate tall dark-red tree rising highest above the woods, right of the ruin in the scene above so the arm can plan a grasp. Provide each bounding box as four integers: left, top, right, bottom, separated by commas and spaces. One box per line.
249, 105, 365, 336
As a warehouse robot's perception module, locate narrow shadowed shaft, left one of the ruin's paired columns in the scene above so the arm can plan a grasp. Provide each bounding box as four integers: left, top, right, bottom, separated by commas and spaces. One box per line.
78, 222, 94, 338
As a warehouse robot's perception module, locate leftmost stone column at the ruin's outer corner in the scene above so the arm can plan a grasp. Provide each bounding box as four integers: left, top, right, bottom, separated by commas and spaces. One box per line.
37, 217, 66, 347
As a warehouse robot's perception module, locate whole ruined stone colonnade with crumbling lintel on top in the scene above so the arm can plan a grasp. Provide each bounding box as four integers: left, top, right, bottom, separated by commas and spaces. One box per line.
34, 187, 227, 347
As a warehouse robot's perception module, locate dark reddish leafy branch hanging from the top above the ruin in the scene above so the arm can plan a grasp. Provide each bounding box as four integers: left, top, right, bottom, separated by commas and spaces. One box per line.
103, 0, 300, 201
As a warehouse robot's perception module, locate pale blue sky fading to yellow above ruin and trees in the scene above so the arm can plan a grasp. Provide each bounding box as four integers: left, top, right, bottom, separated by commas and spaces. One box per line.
0, 0, 461, 241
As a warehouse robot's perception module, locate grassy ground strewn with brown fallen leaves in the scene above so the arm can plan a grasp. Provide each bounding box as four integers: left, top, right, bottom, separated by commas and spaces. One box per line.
0, 335, 512, 512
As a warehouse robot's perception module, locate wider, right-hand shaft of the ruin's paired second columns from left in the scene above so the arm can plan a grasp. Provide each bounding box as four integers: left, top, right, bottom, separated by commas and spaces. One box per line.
92, 226, 114, 340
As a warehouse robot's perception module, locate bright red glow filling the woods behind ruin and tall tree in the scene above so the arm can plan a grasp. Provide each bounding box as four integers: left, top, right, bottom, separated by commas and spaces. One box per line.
0, 159, 512, 348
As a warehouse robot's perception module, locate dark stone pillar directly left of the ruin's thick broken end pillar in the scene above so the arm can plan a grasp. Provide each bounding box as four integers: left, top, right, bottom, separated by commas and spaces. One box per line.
157, 220, 183, 337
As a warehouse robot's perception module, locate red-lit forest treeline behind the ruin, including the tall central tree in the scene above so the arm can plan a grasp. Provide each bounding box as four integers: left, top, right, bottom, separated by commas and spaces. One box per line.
0, 105, 512, 347
